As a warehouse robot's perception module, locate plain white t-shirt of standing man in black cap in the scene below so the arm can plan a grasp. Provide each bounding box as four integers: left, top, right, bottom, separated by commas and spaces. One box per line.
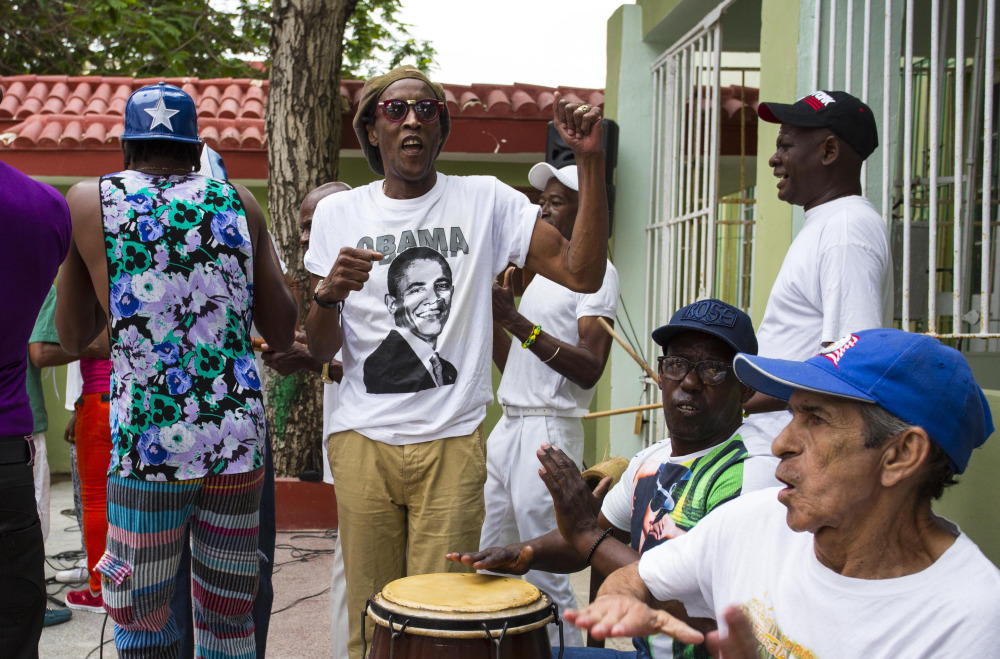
747, 196, 892, 440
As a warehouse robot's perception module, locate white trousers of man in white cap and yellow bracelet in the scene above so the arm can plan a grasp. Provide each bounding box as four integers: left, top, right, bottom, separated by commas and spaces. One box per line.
479, 414, 583, 647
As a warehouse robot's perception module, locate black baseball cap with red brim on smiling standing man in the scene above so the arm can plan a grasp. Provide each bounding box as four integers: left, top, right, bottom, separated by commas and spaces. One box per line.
757, 91, 878, 160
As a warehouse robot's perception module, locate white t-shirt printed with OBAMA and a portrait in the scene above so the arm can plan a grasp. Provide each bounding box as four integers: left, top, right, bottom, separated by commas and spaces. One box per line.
305, 173, 538, 445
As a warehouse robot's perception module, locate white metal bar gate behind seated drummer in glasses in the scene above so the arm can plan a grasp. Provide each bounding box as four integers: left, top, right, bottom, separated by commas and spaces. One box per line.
642, 0, 755, 445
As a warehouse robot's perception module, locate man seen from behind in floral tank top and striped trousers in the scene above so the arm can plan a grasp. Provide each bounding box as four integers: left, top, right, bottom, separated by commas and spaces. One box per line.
56, 82, 297, 659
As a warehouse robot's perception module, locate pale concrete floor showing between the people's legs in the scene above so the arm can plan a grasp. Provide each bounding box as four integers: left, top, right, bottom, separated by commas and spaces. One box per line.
38, 477, 631, 659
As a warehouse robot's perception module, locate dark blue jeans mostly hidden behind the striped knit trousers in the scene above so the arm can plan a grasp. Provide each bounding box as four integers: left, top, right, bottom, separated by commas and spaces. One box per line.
170, 438, 277, 659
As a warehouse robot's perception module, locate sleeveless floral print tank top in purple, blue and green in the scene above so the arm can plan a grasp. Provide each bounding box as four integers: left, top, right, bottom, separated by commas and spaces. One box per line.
100, 171, 266, 481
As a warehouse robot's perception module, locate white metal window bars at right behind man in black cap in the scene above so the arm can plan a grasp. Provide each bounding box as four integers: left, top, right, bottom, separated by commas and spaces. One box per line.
808, 0, 1000, 340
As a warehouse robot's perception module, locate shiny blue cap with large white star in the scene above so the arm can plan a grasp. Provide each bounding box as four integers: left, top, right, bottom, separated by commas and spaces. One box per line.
121, 82, 201, 144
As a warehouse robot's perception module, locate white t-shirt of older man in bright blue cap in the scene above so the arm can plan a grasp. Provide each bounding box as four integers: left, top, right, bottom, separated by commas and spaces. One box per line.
639, 489, 1000, 659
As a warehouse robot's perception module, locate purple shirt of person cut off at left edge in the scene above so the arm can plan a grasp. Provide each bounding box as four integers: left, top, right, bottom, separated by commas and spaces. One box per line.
0, 162, 71, 437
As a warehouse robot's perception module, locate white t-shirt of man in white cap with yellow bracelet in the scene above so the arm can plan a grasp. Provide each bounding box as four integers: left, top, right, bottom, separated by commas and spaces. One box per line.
497, 261, 618, 416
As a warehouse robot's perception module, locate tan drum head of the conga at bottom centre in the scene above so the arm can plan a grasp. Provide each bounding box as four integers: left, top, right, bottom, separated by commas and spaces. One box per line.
382, 573, 541, 613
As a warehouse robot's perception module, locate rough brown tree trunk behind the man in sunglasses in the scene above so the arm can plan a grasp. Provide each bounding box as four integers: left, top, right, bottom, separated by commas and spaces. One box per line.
262, 0, 357, 476
